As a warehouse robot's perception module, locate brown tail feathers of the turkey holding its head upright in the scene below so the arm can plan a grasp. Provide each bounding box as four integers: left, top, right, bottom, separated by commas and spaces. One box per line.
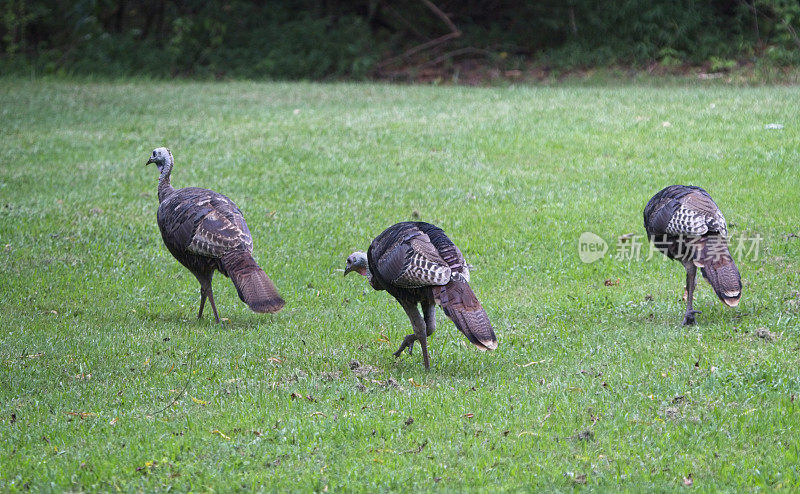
220, 250, 286, 313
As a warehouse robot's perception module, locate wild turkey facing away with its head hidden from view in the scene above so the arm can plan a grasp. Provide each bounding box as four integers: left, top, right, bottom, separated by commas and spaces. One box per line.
644, 185, 742, 325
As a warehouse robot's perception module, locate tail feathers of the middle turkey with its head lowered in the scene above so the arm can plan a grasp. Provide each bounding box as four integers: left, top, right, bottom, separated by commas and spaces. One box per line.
434, 277, 497, 350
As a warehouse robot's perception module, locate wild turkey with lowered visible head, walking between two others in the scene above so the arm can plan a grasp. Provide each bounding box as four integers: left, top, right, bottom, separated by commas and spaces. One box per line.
344, 221, 497, 369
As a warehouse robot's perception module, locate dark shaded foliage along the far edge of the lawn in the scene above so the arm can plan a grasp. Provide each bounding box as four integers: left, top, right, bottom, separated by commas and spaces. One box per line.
0, 0, 800, 79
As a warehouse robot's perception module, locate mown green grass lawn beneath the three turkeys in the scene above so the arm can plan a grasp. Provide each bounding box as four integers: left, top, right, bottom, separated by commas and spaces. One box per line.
0, 79, 800, 492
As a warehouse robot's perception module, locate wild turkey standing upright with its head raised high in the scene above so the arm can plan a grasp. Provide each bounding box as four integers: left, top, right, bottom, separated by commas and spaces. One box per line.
145, 148, 284, 322
